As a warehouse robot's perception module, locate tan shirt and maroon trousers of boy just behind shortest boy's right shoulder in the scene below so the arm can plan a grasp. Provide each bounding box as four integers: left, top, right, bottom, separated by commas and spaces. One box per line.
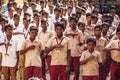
95, 36, 109, 80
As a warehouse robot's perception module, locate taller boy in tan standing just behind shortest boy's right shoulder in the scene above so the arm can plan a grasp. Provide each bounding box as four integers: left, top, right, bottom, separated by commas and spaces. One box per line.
94, 25, 108, 80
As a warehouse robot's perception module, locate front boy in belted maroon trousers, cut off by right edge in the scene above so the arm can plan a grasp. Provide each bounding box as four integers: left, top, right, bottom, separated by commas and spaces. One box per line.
104, 26, 120, 80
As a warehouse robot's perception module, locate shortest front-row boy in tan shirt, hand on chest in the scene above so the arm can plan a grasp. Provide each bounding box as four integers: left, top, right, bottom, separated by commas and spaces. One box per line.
80, 38, 101, 80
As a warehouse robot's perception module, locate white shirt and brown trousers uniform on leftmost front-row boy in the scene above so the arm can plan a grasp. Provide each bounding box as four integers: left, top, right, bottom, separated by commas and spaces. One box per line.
0, 36, 18, 80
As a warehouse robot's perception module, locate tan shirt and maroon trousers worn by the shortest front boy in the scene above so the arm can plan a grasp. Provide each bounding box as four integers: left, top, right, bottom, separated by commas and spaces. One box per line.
80, 50, 101, 80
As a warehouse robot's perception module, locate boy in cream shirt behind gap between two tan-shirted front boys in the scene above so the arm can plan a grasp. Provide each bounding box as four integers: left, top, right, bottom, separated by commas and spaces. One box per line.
37, 19, 53, 79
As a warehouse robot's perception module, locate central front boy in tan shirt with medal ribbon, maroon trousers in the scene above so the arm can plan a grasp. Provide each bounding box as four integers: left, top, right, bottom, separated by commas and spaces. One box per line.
45, 23, 70, 80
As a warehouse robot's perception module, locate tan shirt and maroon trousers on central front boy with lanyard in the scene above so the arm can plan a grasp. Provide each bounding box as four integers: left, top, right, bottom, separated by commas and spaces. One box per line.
46, 36, 70, 80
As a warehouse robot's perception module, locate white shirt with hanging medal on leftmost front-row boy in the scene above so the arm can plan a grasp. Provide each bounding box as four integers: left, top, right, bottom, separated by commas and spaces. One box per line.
0, 36, 18, 67
